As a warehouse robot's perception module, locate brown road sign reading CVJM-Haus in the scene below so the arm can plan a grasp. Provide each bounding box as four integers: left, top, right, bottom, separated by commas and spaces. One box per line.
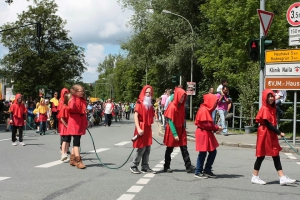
265, 76, 300, 90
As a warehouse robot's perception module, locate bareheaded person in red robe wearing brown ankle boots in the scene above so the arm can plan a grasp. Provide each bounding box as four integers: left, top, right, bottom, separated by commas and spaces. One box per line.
66, 84, 88, 169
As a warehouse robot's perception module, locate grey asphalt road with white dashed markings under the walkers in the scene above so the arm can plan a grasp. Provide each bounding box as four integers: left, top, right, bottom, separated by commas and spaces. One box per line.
0, 120, 300, 200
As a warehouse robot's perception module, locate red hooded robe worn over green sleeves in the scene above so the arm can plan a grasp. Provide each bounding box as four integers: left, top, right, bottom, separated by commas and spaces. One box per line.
164, 88, 187, 147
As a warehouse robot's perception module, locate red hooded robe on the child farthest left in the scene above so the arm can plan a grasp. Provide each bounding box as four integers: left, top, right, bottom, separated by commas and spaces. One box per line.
10, 94, 26, 126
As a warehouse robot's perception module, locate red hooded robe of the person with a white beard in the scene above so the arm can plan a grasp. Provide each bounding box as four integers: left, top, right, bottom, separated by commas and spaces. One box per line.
133, 85, 154, 148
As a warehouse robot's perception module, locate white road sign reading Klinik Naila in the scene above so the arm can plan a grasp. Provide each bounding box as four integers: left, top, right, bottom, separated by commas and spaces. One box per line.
265, 63, 300, 76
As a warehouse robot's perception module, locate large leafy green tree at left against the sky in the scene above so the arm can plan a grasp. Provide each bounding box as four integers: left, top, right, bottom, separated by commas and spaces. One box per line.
1, 0, 86, 95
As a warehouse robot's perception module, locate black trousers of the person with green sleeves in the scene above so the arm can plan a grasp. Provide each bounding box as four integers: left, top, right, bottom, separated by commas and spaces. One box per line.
164, 146, 192, 169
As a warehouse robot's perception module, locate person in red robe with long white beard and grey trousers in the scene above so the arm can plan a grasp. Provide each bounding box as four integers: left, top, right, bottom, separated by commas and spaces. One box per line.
130, 85, 155, 174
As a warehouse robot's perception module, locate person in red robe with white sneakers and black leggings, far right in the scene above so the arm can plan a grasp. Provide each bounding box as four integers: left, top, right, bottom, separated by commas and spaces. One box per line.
251, 89, 296, 185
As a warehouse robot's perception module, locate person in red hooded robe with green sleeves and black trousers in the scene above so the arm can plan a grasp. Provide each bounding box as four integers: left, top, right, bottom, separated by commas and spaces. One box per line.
164, 87, 195, 173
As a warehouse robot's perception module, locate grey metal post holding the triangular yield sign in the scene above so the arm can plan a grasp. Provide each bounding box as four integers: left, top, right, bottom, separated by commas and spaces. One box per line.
259, 0, 265, 108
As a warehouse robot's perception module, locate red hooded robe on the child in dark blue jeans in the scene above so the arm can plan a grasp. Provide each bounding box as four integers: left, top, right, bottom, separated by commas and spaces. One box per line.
195, 94, 219, 151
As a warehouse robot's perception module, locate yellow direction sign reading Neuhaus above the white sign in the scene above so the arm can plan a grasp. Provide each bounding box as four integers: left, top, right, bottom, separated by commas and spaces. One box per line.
265, 49, 300, 64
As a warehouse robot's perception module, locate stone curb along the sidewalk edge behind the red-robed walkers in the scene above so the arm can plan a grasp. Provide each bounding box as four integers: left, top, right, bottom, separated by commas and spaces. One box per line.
157, 122, 300, 153
